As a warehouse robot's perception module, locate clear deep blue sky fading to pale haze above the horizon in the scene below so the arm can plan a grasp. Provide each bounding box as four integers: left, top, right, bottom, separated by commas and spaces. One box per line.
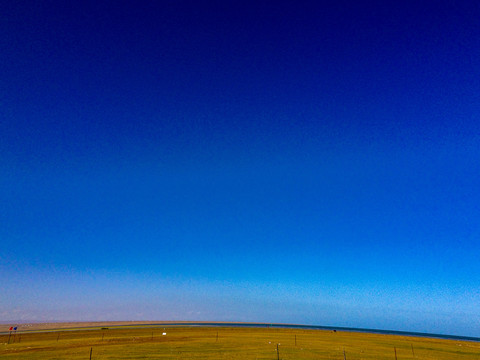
0, 0, 480, 336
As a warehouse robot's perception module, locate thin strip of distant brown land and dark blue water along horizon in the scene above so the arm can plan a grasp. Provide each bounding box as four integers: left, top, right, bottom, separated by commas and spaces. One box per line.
0, 320, 480, 342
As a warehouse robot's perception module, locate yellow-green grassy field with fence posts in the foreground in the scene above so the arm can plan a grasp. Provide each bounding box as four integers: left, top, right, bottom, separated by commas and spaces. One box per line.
0, 325, 480, 360
